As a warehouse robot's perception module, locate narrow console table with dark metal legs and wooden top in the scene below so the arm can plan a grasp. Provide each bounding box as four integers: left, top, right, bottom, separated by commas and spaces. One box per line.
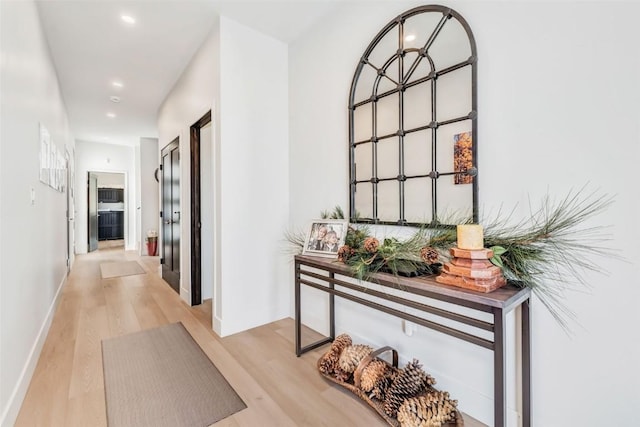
295, 255, 531, 427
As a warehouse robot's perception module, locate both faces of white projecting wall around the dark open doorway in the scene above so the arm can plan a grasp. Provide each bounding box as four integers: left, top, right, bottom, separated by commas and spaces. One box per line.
159, 17, 290, 336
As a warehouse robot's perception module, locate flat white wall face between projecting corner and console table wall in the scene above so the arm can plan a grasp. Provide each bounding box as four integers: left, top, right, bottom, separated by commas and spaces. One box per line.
214, 17, 291, 335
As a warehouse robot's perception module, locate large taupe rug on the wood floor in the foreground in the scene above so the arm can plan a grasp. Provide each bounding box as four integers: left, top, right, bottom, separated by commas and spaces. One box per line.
102, 322, 247, 427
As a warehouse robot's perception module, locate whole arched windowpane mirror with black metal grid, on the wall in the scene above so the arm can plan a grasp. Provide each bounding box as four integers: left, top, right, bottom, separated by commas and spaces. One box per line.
349, 5, 478, 227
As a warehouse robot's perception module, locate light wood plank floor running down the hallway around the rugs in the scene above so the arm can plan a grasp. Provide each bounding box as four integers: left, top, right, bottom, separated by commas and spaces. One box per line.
16, 248, 481, 427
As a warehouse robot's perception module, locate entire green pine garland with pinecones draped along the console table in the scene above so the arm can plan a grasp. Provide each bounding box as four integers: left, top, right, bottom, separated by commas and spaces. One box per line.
286, 187, 621, 332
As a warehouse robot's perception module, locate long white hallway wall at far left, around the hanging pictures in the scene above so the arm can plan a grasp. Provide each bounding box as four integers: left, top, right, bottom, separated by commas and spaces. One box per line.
0, 1, 74, 426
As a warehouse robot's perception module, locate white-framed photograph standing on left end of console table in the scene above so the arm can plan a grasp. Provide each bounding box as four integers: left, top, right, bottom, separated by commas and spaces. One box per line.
302, 219, 349, 258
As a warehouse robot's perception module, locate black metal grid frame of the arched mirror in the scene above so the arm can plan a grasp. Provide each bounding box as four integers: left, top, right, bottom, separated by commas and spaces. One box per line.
349, 5, 478, 226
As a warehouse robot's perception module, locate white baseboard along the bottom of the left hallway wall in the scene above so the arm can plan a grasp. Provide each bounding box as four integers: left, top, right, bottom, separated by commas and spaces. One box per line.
0, 274, 67, 427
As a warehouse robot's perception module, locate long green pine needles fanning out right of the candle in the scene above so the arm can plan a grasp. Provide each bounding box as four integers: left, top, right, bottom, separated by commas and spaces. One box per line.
483, 188, 617, 331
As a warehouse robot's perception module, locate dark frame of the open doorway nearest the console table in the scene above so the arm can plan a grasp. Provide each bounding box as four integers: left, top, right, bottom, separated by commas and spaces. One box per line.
190, 110, 211, 305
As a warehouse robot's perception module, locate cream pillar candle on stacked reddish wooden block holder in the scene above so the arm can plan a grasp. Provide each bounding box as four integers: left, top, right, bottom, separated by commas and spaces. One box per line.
436, 224, 506, 292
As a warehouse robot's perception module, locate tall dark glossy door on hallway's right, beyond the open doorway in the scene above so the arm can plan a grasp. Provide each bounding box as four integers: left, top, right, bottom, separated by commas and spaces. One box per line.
160, 138, 180, 293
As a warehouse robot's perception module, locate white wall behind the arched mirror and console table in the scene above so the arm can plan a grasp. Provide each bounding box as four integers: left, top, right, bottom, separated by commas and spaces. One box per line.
289, 2, 640, 427
